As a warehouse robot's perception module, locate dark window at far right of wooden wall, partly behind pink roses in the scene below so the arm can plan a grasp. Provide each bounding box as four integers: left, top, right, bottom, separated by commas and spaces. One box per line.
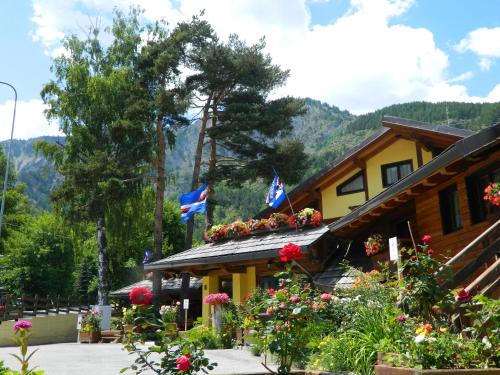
465, 164, 500, 224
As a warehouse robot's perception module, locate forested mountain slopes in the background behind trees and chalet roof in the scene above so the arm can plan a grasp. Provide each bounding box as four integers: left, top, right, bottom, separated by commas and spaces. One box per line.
3, 98, 500, 222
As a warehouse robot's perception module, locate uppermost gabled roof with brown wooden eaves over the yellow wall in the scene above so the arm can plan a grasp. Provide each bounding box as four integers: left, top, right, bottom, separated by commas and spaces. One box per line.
255, 116, 474, 219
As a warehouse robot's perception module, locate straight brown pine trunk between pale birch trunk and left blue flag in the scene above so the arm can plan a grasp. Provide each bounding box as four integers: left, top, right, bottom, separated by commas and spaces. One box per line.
153, 117, 165, 304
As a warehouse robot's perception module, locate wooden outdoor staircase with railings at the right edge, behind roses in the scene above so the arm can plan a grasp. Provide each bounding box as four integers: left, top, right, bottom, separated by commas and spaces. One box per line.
441, 220, 500, 298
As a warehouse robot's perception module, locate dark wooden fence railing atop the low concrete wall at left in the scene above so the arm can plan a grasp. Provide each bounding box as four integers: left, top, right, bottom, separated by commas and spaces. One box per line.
0, 295, 91, 322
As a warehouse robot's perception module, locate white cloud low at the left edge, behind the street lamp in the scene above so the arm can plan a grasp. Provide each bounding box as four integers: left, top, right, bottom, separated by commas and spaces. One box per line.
0, 99, 62, 141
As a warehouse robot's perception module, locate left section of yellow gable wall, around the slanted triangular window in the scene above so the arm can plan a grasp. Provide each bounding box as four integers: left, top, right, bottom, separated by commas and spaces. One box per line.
321, 167, 365, 219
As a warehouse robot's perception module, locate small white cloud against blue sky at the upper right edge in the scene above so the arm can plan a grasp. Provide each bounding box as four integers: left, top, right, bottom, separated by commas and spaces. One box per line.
455, 27, 500, 71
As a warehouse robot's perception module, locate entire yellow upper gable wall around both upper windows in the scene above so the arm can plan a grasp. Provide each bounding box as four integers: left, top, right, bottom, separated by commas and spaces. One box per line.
321, 139, 432, 219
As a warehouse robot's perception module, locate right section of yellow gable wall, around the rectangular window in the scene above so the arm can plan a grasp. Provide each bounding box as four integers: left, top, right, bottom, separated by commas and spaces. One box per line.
366, 139, 424, 199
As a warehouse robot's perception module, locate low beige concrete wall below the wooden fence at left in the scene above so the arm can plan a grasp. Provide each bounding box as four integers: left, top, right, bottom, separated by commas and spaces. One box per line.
0, 314, 78, 347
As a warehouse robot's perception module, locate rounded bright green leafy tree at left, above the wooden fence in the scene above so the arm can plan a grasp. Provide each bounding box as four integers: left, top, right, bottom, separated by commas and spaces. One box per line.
0, 213, 74, 296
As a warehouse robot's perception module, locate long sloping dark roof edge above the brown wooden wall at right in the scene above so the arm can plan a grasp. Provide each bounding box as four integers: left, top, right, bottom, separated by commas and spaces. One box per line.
329, 123, 500, 232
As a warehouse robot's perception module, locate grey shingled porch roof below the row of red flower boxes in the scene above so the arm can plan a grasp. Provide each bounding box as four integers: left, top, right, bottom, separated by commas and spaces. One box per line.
144, 226, 329, 271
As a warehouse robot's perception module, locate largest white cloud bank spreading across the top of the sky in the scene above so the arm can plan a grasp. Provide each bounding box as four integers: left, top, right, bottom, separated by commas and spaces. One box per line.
33, 0, 500, 114
